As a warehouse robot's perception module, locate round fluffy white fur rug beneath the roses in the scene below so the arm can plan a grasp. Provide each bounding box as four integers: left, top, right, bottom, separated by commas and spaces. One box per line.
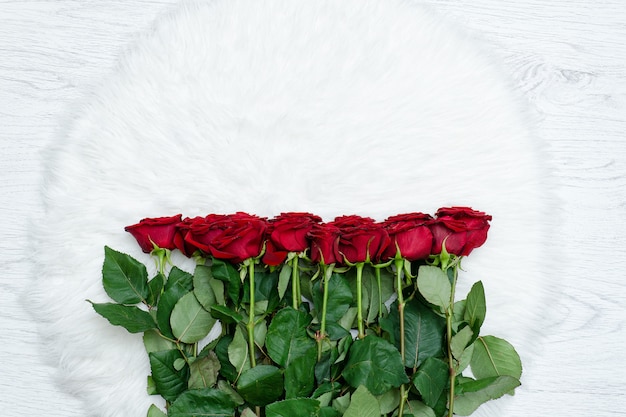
32, 0, 552, 417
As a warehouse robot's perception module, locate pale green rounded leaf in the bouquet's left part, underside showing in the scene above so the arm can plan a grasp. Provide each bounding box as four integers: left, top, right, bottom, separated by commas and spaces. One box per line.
170, 292, 215, 343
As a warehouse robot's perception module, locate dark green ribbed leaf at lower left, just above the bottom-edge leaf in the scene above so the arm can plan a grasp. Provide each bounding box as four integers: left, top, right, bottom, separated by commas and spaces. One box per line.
148, 349, 189, 402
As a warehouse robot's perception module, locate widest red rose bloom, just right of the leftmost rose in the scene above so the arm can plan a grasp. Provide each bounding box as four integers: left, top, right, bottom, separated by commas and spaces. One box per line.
186, 212, 267, 263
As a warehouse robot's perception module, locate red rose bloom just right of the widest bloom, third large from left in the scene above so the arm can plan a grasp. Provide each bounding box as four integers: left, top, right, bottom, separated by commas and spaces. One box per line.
263, 213, 322, 265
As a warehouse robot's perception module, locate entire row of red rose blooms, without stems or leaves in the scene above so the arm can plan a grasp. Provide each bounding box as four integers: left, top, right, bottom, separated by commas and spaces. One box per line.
125, 207, 491, 266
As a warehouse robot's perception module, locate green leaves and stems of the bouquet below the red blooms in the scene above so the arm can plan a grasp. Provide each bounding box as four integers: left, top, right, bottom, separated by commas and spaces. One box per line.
92, 248, 522, 417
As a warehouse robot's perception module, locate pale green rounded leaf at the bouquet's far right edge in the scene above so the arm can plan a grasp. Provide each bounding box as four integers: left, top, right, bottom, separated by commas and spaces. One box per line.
470, 336, 522, 379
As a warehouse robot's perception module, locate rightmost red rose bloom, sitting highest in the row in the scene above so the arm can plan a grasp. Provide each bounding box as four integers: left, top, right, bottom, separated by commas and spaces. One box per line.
430, 207, 491, 256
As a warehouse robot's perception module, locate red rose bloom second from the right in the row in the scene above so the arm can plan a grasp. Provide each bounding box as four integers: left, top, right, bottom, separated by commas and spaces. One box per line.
382, 213, 433, 261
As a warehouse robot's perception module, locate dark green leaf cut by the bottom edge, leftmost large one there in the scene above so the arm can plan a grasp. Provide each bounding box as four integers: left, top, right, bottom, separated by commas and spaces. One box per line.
169, 388, 235, 417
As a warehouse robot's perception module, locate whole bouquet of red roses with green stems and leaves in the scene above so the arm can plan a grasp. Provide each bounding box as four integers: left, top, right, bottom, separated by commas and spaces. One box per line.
92, 207, 522, 417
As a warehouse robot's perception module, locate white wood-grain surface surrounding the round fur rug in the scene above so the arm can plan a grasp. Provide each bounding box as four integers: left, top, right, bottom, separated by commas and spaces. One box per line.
0, 0, 626, 417
